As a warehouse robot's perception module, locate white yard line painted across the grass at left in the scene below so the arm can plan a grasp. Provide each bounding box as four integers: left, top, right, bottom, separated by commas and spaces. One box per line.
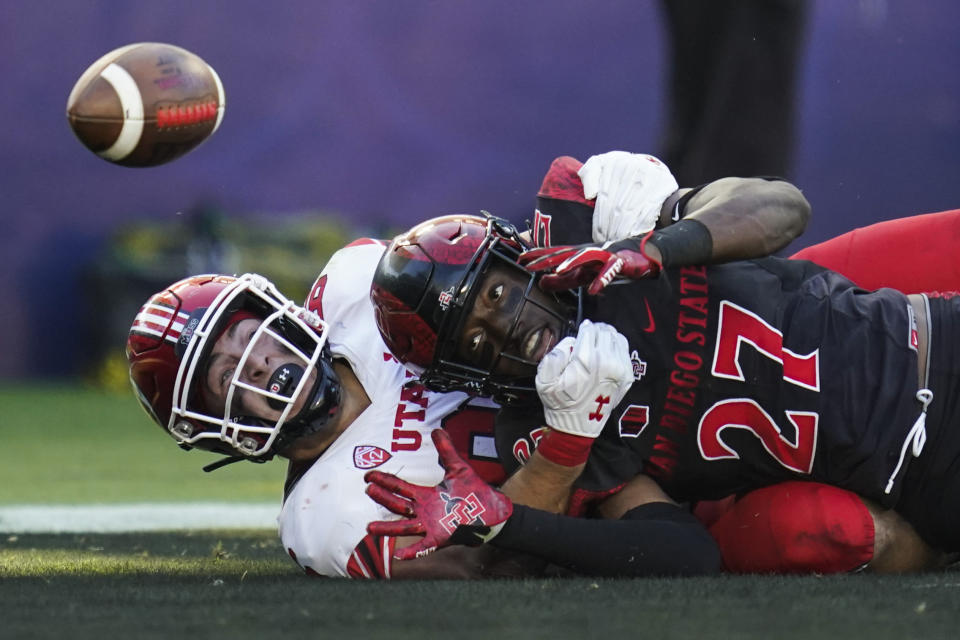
0, 502, 280, 533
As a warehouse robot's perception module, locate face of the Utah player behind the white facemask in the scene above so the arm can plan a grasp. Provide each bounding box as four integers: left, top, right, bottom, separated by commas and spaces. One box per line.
201, 318, 317, 422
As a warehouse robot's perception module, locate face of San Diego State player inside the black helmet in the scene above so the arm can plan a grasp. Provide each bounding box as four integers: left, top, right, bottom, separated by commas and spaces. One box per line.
457, 263, 564, 375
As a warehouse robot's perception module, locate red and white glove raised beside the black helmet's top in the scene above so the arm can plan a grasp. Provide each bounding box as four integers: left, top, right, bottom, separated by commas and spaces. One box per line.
519, 234, 661, 295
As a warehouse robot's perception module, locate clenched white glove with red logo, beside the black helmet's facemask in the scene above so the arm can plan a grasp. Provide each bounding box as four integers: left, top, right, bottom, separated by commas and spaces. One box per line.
536, 320, 633, 438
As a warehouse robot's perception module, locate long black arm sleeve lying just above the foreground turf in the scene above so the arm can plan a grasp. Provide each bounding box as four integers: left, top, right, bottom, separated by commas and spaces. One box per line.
491, 502, 720, 577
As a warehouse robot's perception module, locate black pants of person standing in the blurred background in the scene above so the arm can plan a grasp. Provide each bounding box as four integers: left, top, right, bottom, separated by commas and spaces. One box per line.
661, 0, 807, 186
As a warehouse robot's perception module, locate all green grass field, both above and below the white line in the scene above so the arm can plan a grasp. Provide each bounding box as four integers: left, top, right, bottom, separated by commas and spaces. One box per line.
0, 387, 960, 640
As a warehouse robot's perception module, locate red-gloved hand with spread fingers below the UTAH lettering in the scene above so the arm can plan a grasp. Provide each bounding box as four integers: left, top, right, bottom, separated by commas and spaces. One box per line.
364, 429, 513, 560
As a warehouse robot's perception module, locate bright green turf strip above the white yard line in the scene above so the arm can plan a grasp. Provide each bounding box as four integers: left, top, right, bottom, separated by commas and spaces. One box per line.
0, 386, 286, 504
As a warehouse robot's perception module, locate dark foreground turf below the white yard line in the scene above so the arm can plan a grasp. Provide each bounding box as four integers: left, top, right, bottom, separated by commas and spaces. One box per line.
0, 531, 960, 640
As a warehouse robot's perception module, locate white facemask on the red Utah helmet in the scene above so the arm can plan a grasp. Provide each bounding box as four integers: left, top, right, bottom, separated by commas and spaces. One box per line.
167, 274, 340, 461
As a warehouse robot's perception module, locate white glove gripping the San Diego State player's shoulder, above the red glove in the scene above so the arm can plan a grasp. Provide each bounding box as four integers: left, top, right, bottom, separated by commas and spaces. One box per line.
577, 151, 678, 242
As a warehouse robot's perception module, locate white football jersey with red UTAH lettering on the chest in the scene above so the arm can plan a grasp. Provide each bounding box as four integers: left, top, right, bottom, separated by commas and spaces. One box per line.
279, 240, 496, 578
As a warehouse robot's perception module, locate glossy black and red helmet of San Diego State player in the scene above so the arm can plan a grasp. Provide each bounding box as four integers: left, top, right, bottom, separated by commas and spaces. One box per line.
370, 212, 578, 402
